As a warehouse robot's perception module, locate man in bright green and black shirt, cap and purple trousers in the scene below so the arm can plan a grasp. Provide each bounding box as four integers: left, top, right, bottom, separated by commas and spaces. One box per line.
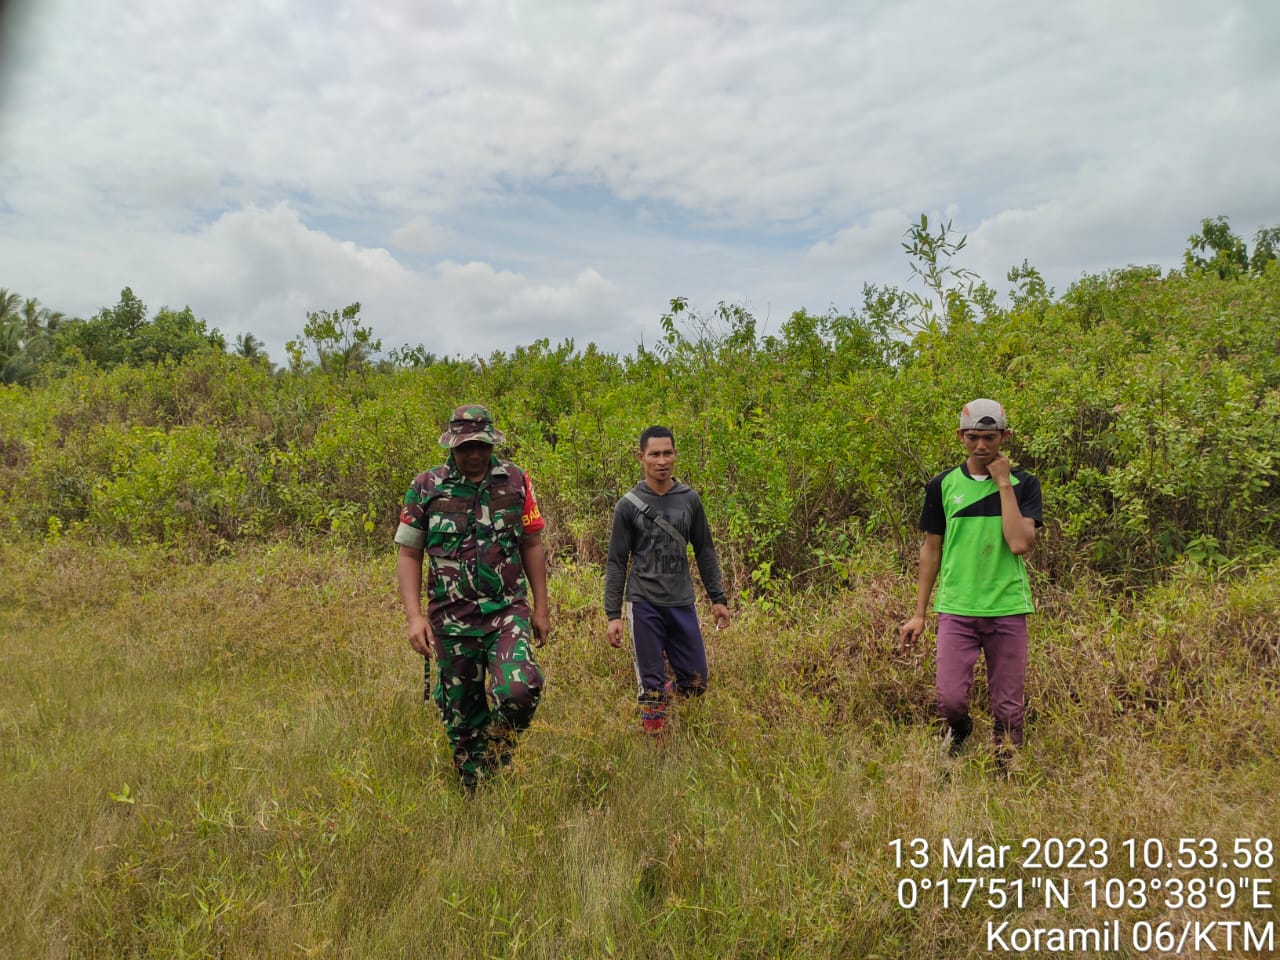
901, 399, 1043, 758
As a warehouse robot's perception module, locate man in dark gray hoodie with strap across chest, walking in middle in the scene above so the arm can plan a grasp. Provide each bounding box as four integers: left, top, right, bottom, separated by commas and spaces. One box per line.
604, 426, 730, 735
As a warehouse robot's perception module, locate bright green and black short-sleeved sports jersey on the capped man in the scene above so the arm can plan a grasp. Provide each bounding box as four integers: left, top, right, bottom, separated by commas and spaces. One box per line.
920, 463, 1044, 617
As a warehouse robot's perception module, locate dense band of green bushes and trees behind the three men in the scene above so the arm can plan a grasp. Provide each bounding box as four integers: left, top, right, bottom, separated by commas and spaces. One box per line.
0, 218, 1280, 591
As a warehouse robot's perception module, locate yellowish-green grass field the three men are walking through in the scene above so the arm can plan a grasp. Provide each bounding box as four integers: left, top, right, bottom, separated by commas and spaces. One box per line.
0, 544, 1280, 960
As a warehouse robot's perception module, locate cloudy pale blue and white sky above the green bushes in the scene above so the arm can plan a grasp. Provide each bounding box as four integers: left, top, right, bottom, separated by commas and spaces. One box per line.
0, 0, 1280, 362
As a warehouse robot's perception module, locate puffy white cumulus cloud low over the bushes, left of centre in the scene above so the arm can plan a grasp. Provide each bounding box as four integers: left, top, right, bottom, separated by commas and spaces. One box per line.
156, 204, 620, 357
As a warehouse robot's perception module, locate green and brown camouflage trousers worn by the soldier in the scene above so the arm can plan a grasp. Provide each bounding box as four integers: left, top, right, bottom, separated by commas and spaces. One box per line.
426, 616, 543, 788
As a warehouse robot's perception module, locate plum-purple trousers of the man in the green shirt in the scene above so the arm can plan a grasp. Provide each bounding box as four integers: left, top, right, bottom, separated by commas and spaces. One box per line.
936, 613, 1027, 746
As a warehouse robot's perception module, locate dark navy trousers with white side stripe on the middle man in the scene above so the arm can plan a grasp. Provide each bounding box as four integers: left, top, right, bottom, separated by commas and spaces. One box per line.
623, 603, 707, 700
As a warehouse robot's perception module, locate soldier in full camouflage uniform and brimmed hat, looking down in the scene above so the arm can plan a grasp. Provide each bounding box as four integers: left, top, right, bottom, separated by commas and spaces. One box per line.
396, 404, 550, 791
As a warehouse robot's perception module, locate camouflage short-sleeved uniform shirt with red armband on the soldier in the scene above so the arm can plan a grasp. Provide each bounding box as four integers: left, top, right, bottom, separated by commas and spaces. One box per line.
396, 457, 543, 636
